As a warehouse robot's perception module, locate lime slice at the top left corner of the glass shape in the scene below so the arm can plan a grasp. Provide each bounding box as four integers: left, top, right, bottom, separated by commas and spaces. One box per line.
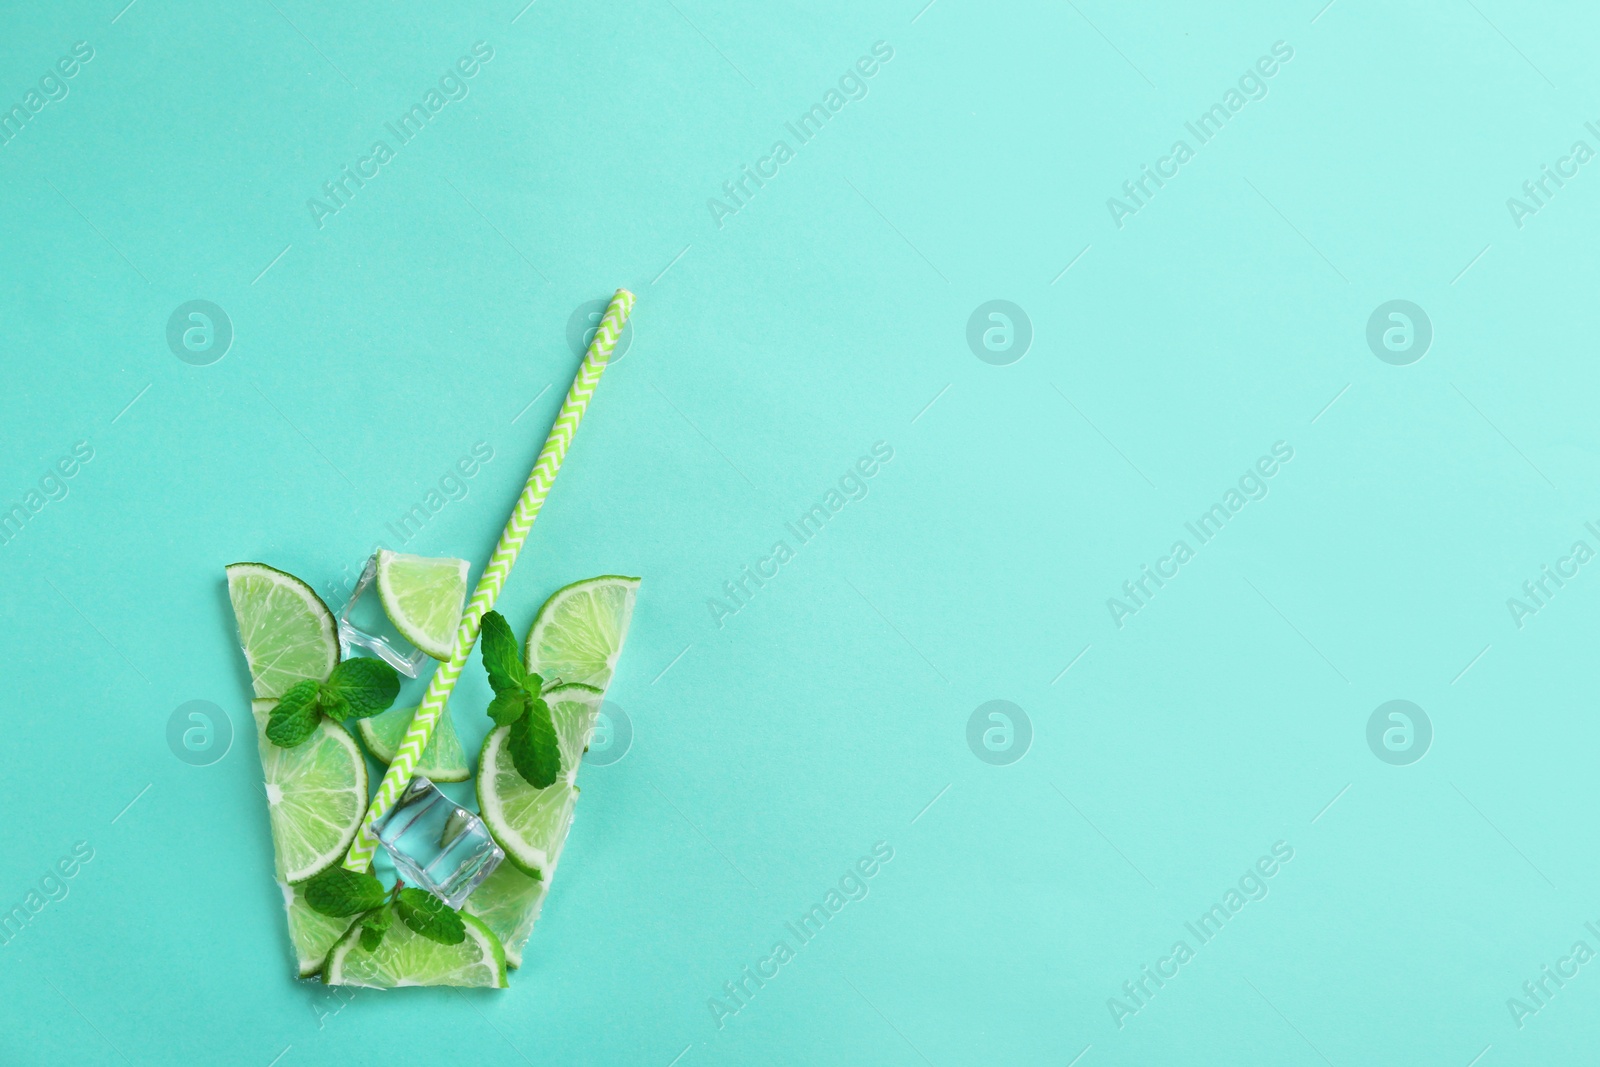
227, 563, 339, 699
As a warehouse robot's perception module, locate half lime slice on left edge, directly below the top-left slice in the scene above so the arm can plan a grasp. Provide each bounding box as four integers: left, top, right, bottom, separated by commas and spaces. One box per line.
251, 701, 366, 883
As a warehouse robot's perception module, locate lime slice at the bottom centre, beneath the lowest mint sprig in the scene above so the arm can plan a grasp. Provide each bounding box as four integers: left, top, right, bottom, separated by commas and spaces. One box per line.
322, 915, 506, 989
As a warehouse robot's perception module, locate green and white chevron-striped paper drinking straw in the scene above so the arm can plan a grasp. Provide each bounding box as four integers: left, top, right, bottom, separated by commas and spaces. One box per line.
344, 290, 634, 870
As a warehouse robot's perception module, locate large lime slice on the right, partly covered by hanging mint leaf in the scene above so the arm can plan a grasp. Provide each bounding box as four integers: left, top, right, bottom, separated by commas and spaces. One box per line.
478, 685, 605, 880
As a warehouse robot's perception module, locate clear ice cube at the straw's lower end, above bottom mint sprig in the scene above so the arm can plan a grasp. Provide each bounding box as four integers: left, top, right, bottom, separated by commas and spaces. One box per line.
378, 774, 506, 907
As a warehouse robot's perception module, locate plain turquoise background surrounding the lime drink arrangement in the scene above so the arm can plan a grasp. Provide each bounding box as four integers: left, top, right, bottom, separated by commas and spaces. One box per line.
0, 0, 1600, 1067
